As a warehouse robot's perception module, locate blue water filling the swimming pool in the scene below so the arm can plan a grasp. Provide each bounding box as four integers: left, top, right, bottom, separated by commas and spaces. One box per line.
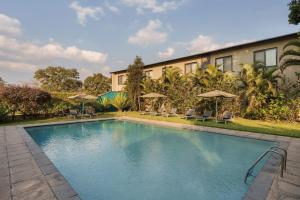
27, 121, 272, 200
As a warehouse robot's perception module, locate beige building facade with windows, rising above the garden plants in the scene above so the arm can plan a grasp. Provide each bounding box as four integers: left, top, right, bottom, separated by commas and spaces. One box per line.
111, 33, 300, 91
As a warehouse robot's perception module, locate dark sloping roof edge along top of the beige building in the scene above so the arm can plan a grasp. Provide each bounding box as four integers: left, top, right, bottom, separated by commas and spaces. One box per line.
110, 33, 298, 73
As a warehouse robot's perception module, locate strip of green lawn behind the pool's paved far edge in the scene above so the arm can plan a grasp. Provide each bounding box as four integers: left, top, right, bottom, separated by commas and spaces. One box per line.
0, 112, 300, 138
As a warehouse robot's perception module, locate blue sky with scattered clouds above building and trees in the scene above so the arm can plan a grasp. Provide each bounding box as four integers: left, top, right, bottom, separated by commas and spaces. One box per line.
0, 0, 299, 84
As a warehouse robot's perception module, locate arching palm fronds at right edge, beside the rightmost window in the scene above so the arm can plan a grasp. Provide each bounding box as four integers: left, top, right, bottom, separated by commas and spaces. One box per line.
280, 38, 300, 72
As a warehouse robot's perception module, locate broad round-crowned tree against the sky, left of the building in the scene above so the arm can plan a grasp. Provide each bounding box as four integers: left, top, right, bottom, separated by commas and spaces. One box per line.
34, 66, 82, 92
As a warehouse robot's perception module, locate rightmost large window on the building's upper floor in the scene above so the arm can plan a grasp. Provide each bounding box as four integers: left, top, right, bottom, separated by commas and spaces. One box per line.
254, 48, 277, 67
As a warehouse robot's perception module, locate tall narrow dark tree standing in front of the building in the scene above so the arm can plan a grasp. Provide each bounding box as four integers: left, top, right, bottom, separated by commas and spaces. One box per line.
126, 56, 144, 110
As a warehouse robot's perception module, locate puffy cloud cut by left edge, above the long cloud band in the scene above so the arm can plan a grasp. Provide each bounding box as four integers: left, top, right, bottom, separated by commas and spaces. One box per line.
0, 13, 21, 36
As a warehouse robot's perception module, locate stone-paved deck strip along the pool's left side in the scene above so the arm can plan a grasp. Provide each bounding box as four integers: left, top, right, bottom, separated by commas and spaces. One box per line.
0, 126, 79, 200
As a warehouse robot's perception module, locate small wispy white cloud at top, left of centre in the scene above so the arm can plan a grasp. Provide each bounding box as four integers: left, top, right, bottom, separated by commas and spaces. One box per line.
70, 1, 104, 26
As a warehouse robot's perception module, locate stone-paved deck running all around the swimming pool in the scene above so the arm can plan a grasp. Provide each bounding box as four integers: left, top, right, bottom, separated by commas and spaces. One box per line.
0, 117, 300, 200
